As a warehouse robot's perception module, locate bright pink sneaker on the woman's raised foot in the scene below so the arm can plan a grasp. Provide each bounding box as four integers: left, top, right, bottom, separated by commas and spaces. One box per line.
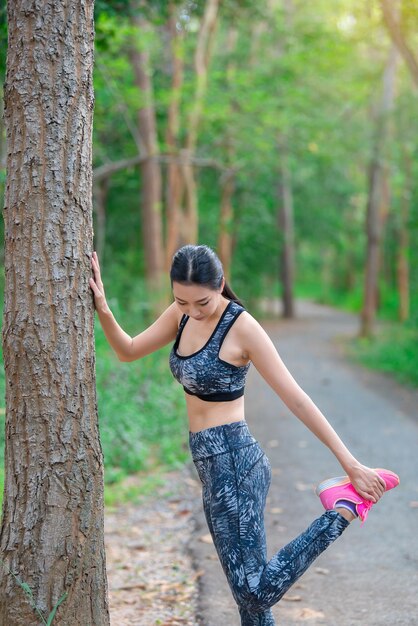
315, 468, 399, 525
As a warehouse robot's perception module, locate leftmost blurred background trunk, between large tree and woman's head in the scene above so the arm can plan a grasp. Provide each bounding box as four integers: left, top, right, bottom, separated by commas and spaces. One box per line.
130, 12, 164, 294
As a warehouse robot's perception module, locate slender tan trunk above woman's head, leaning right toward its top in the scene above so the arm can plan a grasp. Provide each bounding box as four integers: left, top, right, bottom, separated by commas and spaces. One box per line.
181, 0, 220, 243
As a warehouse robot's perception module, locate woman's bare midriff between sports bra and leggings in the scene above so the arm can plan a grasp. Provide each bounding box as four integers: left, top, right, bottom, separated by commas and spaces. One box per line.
185, 393, 245, 433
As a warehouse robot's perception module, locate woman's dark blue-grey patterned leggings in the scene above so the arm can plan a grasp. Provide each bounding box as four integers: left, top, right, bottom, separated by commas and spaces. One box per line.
190, 421, 348, 626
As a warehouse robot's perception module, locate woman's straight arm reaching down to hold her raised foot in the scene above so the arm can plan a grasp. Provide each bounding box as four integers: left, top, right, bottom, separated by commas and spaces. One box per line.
240, 313, 385, 502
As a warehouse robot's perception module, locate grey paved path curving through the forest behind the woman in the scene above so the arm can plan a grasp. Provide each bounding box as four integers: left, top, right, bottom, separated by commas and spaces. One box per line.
191, 304, 418, 626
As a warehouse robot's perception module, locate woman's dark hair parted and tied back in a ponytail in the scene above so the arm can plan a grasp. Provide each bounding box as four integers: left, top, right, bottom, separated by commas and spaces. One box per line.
170, 244, 243, 306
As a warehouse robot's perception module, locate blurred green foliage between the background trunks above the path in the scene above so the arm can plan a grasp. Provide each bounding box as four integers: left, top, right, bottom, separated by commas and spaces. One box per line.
88, 0, 418, 366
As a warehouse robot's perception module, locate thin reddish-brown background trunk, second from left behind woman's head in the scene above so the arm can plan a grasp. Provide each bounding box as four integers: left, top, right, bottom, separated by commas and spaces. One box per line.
165, 1, 184, 271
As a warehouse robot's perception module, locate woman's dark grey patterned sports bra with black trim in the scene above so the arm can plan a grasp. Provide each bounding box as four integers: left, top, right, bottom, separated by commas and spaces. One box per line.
170, 300, 250, 402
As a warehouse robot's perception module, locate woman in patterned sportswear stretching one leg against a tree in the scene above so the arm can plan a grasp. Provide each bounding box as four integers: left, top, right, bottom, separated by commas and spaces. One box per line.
90, 245, 399, 626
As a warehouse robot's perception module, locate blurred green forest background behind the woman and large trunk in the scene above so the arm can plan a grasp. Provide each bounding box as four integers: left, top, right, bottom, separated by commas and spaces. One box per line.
0, 0, 418, 503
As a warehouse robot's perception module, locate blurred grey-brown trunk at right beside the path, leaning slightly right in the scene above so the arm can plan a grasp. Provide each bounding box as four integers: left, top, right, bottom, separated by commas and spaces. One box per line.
360, 46, 397, 337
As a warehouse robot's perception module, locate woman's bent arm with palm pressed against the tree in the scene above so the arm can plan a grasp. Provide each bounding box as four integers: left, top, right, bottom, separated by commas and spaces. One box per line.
90, 252, 179, 361
